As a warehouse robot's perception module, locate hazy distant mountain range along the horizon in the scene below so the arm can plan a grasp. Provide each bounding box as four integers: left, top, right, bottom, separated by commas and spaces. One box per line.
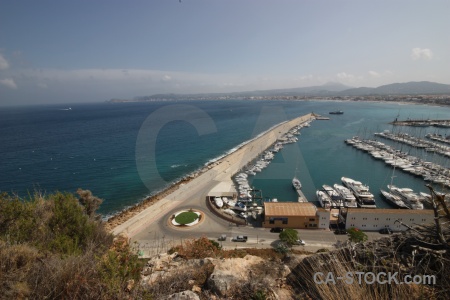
110, 81, 450, 102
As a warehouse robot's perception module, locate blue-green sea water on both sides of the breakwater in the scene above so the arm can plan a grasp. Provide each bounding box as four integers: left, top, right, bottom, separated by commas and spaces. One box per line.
0, 100, 450, 216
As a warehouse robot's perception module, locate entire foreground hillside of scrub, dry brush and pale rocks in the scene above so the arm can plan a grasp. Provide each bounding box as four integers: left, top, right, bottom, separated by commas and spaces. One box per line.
0, 190, 450, 300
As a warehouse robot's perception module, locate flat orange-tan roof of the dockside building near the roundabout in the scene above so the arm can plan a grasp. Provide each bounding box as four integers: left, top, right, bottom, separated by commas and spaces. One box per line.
264, 202, 317, 217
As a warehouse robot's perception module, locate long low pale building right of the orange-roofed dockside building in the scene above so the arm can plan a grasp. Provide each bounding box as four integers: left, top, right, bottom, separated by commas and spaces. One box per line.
341, 208, 434, 231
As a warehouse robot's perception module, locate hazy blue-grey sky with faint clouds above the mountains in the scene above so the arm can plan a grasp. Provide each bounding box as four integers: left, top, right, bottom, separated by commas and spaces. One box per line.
0, 0, 450, 106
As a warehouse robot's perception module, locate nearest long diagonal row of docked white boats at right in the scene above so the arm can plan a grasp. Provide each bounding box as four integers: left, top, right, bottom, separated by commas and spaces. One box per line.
345, 137, 450, 187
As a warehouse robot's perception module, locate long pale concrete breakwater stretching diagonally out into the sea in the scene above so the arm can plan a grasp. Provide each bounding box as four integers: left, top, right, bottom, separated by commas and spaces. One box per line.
106, 114, 315, 237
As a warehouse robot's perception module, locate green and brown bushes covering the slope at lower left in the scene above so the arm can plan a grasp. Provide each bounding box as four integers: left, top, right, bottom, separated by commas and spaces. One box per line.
0, 190, 149, 299
